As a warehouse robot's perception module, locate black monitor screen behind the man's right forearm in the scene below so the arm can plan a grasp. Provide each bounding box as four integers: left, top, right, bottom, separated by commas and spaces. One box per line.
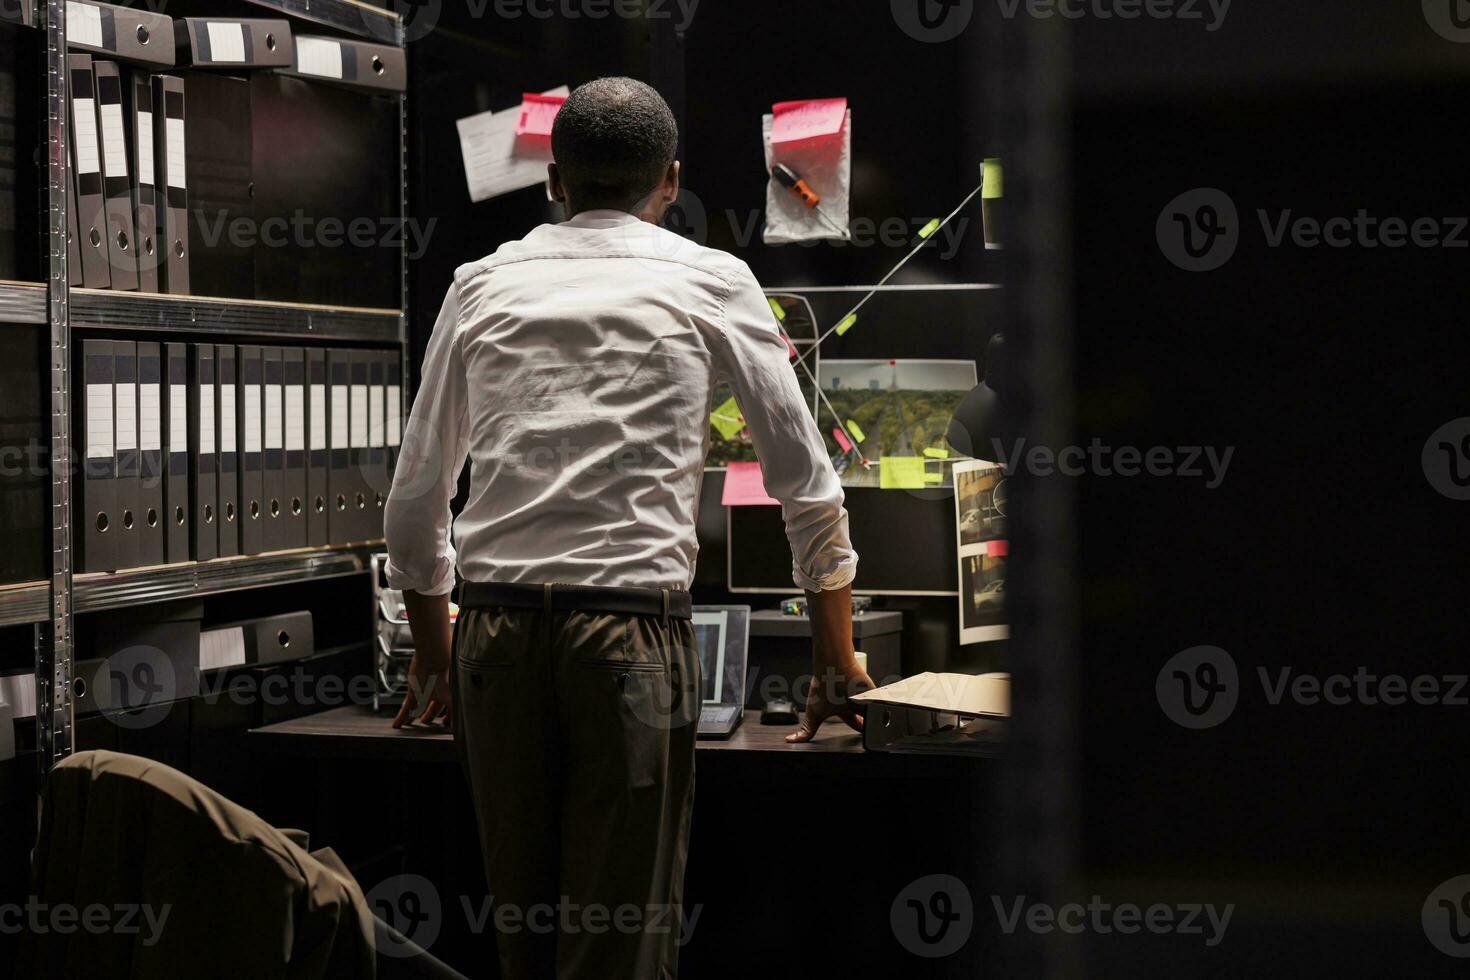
725, 486, 960, 595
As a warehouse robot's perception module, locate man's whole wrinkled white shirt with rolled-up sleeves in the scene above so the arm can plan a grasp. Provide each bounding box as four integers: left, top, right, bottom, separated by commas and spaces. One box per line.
385, 212, 857, 595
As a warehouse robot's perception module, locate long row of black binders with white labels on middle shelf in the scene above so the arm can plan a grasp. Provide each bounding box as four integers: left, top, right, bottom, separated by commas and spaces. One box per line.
72, 339, 403, 572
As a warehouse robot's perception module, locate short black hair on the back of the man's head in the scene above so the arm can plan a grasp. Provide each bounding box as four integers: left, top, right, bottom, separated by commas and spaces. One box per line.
551, 76, 679, 209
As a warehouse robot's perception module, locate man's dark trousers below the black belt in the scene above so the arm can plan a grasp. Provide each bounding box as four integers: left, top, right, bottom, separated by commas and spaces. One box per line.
454, 608, 701, 980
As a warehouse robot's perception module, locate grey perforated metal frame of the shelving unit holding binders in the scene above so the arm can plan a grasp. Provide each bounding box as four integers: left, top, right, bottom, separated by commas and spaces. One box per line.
18, 0, 409, 773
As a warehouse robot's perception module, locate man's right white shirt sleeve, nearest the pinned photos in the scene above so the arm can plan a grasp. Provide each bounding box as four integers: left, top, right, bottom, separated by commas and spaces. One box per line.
720, 263, 857, 592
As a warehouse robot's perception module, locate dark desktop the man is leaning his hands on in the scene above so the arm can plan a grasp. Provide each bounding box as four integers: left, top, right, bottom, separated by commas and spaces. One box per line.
248, 705, 976, 777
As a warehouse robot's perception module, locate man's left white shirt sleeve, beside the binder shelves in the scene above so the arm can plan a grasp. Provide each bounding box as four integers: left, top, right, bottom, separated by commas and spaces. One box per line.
384, 285, 467, 595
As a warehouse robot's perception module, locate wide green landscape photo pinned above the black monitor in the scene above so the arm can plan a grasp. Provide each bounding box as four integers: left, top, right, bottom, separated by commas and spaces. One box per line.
817, 359, 976, 488
